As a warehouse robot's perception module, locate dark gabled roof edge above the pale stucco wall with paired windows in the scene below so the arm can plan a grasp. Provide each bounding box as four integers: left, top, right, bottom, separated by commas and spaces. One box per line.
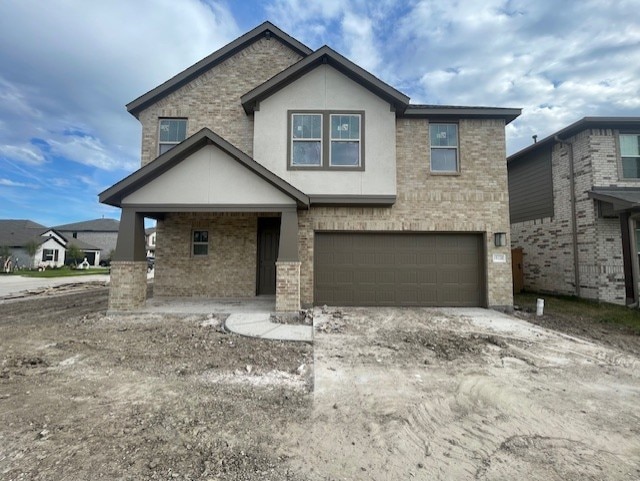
240, 45, 409, 114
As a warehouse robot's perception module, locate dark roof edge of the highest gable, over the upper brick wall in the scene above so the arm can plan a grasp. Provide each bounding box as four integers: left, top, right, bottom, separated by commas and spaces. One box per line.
127, 22, 313, 118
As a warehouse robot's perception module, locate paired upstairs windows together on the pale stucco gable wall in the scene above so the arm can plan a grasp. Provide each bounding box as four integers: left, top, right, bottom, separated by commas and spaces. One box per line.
288, 111, 364, 170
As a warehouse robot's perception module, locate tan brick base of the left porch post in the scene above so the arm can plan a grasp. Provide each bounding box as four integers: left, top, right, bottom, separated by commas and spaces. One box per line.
108, 261, 147, 314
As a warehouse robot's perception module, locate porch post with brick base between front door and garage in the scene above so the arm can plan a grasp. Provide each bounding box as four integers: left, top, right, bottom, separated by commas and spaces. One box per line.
276, 209, 300, 312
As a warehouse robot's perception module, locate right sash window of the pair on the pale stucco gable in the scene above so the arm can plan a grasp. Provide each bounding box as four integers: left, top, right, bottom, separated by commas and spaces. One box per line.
329, 114, 361, 167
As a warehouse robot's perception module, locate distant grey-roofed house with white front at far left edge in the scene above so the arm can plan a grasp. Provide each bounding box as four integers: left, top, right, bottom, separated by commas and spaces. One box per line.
0, 219, 65, 270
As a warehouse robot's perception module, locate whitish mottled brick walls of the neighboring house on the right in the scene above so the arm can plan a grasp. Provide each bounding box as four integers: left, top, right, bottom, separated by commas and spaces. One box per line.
511, 129, 638, 304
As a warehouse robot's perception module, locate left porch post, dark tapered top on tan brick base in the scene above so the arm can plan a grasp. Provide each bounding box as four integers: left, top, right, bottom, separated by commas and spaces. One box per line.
109, 207, 147, 314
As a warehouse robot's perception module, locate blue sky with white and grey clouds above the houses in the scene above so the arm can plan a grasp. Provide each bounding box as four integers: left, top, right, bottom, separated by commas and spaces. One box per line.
0, 0, 640, 227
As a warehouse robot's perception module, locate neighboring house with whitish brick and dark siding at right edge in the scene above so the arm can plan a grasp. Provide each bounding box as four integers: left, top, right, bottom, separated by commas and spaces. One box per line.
507, 117, 640, 304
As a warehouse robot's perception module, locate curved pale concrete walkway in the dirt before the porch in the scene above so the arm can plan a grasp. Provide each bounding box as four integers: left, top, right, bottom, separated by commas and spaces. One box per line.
224, 312, 313, 342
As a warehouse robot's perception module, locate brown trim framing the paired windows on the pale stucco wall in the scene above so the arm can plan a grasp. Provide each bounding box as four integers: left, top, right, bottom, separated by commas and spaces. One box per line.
286, 109, 366, 172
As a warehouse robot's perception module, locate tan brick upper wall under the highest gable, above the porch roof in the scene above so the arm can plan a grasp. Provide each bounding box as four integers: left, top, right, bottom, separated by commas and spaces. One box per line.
139, 38, 301, 166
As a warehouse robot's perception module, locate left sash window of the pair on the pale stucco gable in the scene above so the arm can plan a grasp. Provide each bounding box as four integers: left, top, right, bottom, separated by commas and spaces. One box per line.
291, 113, 322, 167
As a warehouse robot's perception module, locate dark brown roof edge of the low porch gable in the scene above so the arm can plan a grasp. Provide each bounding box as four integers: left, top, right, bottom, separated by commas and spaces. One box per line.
99, 127, 309, 207
